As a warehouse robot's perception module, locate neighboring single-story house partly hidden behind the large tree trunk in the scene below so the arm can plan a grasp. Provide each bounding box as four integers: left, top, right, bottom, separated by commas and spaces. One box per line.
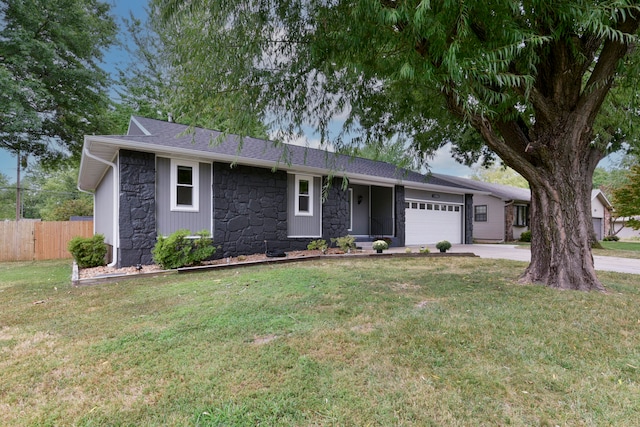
434, 174, 612, 242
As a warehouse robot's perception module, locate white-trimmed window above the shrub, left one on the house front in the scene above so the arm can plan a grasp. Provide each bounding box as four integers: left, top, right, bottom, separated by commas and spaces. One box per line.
171, 159, 200, 212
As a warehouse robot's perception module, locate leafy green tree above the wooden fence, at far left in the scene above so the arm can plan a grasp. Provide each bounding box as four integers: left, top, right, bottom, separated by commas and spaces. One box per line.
0, 0, 116, 166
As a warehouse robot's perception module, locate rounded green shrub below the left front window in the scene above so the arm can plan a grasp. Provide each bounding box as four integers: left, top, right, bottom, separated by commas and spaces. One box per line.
153, 229, 216, 269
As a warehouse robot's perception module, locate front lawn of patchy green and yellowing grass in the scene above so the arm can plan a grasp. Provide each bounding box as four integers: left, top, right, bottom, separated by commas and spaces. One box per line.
0, 258, 640, 426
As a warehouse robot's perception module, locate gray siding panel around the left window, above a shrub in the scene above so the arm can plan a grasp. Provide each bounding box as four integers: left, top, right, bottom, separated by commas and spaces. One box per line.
156, 157, 212, 236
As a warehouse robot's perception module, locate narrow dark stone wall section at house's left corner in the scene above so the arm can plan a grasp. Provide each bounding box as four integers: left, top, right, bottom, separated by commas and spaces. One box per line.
118, 150, 156, 267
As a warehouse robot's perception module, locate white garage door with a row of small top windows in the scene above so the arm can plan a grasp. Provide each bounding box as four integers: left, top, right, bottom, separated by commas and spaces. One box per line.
405, 200, 462, 245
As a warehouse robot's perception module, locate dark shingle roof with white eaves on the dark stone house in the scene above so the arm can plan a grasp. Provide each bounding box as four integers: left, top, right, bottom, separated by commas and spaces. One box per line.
78, 116, 477, 193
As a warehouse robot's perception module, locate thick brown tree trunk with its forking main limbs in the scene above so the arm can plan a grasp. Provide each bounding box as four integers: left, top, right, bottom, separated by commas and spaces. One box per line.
424, 10, 640, 291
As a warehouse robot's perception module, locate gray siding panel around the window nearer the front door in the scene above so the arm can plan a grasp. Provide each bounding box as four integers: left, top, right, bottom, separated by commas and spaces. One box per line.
287, 174, 322, 237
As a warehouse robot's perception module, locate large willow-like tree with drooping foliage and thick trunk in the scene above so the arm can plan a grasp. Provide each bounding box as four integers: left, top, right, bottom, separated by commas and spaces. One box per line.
154, 0, 640, 290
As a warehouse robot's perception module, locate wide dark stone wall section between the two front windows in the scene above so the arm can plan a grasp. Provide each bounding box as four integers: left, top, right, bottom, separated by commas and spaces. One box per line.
213, 163, 309, 258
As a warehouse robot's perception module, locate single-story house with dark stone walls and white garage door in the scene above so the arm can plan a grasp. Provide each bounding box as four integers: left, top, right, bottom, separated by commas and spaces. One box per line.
78, 117, 477, 266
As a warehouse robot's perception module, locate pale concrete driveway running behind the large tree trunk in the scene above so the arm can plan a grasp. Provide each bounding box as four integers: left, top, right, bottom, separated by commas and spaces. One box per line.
440, 244, 640, 274
